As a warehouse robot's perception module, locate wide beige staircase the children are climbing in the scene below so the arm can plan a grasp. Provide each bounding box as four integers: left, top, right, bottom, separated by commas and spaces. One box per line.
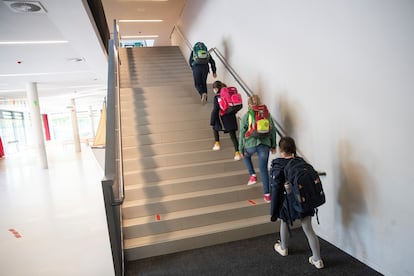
120, 46, 278, 261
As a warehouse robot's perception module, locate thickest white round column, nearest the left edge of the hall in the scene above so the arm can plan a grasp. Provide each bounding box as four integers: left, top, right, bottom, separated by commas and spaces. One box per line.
26, 82, 48, 169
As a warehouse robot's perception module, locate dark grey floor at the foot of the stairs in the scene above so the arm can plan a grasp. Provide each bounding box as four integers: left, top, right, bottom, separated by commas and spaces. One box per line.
126, 228, 382, 276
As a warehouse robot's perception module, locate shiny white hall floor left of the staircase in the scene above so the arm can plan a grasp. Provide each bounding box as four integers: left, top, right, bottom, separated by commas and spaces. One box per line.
0, 143, 114, 276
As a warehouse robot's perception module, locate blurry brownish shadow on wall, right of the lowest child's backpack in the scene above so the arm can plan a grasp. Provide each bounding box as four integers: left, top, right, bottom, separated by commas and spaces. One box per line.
337, 140, 375, 255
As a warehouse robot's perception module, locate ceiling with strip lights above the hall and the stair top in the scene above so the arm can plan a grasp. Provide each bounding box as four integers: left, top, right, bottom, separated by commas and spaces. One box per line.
0, 0, 186, 113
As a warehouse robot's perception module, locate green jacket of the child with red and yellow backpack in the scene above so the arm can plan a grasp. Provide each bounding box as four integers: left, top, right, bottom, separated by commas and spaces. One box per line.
239, 109, 276, 154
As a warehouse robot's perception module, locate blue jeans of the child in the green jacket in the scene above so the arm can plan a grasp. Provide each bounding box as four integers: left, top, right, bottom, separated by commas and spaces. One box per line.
243, 144, 270, 194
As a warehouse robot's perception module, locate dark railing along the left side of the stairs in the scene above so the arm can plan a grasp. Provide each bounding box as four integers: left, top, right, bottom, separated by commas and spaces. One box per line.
101, 20, 125, 276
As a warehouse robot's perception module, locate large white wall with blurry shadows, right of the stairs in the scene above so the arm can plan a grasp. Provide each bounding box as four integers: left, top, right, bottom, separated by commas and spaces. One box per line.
179, 0, 414, 275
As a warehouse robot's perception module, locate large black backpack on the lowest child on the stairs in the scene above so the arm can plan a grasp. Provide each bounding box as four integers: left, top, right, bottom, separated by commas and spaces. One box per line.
284, 157, 326, 220
